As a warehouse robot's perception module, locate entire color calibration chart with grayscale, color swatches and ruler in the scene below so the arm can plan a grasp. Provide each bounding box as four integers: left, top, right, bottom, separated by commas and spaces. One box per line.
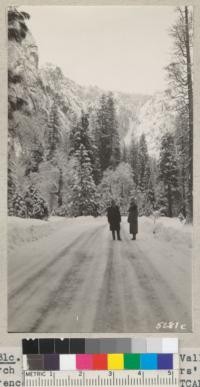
22, 337, 179, 387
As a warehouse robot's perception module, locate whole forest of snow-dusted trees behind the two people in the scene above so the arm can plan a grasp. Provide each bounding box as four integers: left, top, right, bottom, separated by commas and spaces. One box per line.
8, 7, 193, 221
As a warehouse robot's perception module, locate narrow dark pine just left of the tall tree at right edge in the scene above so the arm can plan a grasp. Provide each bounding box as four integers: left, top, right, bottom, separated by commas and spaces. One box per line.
159, 133, 178, 217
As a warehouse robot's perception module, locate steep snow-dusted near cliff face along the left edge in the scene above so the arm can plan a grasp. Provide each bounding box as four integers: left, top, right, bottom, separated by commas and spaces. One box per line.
8, 25, 48, 158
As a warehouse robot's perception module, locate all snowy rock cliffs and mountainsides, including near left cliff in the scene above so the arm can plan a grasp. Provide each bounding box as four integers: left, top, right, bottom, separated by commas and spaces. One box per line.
8, 26, 175, 159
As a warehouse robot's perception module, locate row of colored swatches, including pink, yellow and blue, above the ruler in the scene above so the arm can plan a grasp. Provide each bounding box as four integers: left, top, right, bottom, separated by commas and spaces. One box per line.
23, 353, 178, 371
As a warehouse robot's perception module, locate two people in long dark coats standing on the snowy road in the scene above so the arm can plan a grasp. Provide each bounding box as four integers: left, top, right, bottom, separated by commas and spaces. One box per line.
107, 199, 138, 240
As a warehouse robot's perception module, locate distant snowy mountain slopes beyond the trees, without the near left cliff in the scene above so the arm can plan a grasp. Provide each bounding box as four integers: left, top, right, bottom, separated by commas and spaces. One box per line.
40, 64, 175, 156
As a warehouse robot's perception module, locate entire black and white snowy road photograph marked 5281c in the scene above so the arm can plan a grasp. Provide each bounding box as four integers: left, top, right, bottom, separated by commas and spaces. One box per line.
7, 5, 193, 334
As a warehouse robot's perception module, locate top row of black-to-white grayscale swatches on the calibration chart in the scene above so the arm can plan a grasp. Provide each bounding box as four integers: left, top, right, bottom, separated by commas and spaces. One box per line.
22, 337, 178, 354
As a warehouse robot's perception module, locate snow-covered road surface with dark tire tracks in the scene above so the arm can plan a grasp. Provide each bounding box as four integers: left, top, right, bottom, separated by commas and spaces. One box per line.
8, 217, 191, 332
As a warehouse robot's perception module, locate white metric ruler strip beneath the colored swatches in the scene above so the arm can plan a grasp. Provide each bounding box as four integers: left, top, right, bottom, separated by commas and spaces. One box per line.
23, 370, 179, 387
